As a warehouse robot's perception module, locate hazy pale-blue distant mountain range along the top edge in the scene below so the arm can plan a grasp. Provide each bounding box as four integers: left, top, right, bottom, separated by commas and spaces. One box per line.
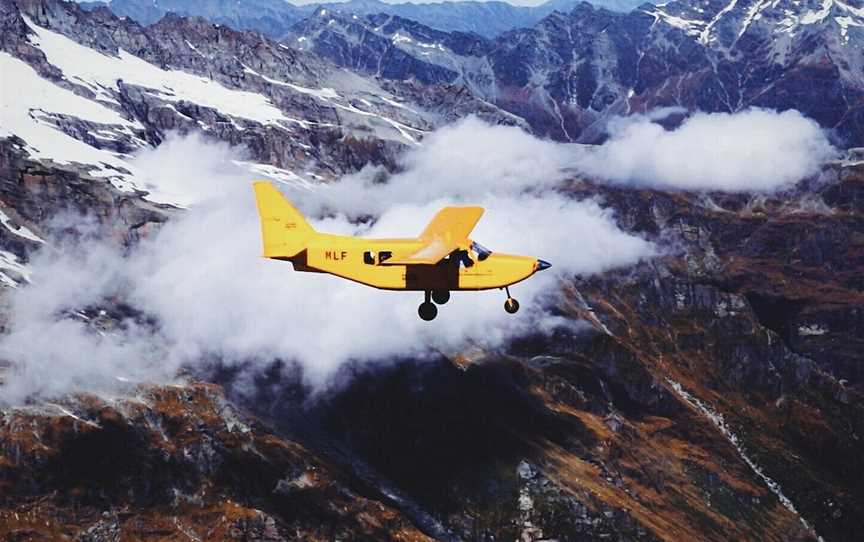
81, 0, 644, 38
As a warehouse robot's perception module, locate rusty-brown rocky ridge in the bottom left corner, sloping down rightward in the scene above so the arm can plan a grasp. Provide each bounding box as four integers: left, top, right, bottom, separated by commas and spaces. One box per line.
0, 384, 428, 541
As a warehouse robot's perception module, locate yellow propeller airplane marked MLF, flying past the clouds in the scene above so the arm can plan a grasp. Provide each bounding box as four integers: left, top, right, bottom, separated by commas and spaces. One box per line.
253, 182, 550, 321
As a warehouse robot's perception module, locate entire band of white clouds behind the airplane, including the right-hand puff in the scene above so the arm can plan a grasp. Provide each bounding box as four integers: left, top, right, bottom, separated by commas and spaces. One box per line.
0, 109, 834, 404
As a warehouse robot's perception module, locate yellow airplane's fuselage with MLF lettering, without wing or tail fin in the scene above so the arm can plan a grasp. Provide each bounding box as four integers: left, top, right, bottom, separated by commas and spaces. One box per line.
281, 234, 540, 291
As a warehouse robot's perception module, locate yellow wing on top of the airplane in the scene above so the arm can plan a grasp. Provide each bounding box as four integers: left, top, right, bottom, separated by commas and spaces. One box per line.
382, 207, 484, 265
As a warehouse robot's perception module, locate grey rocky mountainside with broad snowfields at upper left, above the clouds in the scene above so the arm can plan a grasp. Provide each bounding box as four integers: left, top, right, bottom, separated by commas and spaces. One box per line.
0, 1, 519, 208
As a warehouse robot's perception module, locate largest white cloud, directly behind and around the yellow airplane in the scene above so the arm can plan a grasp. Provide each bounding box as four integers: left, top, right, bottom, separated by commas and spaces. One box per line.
0, 119, 655, 403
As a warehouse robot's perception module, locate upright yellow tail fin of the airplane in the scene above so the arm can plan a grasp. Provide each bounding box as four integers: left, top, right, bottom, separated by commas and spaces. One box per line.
253, 181, 315, 258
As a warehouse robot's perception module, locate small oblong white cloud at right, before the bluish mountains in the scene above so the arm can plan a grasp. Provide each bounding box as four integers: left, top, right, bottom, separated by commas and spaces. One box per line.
576, 108, 835, 192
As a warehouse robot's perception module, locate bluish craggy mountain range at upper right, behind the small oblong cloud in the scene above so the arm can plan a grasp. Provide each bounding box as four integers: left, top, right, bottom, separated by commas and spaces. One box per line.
289, 0, 864, 146
